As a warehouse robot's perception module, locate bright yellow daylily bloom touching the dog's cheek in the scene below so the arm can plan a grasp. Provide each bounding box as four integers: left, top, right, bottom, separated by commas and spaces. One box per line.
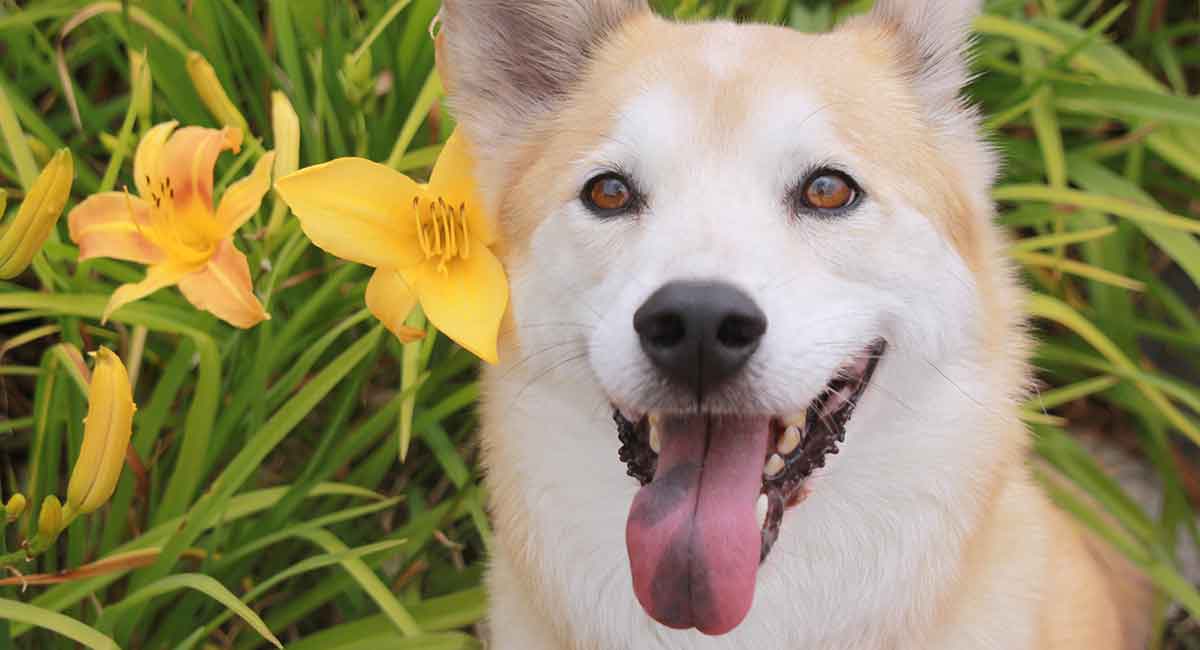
275, 132, 509, 363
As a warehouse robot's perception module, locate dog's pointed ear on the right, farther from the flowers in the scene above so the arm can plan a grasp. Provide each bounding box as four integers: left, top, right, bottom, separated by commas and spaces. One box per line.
859, 0, 983, 112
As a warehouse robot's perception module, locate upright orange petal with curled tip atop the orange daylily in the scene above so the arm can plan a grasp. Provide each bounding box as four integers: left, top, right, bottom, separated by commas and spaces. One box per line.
160, 126, 241, 215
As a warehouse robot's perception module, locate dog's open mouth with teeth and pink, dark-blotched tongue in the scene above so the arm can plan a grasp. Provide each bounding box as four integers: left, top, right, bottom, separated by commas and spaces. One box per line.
613, 339, 887, 634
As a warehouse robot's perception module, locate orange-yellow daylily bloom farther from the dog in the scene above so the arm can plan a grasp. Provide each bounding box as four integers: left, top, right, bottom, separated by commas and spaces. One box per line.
68, 122, 275, 329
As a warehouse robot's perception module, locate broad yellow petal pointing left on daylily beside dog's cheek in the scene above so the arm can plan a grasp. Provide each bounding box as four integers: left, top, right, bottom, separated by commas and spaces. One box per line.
275, 158, 425, 269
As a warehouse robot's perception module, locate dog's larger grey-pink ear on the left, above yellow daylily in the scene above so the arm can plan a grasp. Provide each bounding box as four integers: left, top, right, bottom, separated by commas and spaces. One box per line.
438, 0, 649, 155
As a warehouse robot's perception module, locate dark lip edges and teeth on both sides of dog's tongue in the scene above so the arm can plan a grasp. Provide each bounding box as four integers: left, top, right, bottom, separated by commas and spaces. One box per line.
613, 339, 887, 561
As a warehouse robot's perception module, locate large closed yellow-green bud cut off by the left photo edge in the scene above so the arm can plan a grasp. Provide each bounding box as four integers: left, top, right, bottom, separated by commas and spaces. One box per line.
0, 149, 74, 279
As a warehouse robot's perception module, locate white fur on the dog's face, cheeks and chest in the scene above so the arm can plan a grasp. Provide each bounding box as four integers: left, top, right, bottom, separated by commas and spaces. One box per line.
485, 75, 1036, 650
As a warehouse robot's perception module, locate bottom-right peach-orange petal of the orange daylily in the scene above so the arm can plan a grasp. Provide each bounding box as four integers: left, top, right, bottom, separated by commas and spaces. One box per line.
179, 240, 271, 330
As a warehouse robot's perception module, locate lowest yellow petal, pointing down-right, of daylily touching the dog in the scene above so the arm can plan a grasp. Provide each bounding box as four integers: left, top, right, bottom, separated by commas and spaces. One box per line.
401, 241, 509, 363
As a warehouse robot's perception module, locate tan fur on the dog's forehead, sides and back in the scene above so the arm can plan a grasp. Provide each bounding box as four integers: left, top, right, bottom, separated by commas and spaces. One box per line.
446, 3, 1148, 650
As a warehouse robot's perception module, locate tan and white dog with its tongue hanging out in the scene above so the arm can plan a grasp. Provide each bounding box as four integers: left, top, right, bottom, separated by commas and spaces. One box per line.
438, 0, 1150, 650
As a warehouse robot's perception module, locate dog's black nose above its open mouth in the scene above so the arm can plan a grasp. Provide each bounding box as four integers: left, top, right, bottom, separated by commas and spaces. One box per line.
634, 282, 767, 396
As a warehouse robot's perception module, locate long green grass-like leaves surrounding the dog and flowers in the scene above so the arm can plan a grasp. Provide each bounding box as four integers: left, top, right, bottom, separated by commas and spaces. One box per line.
0, 0, 1200, 649
